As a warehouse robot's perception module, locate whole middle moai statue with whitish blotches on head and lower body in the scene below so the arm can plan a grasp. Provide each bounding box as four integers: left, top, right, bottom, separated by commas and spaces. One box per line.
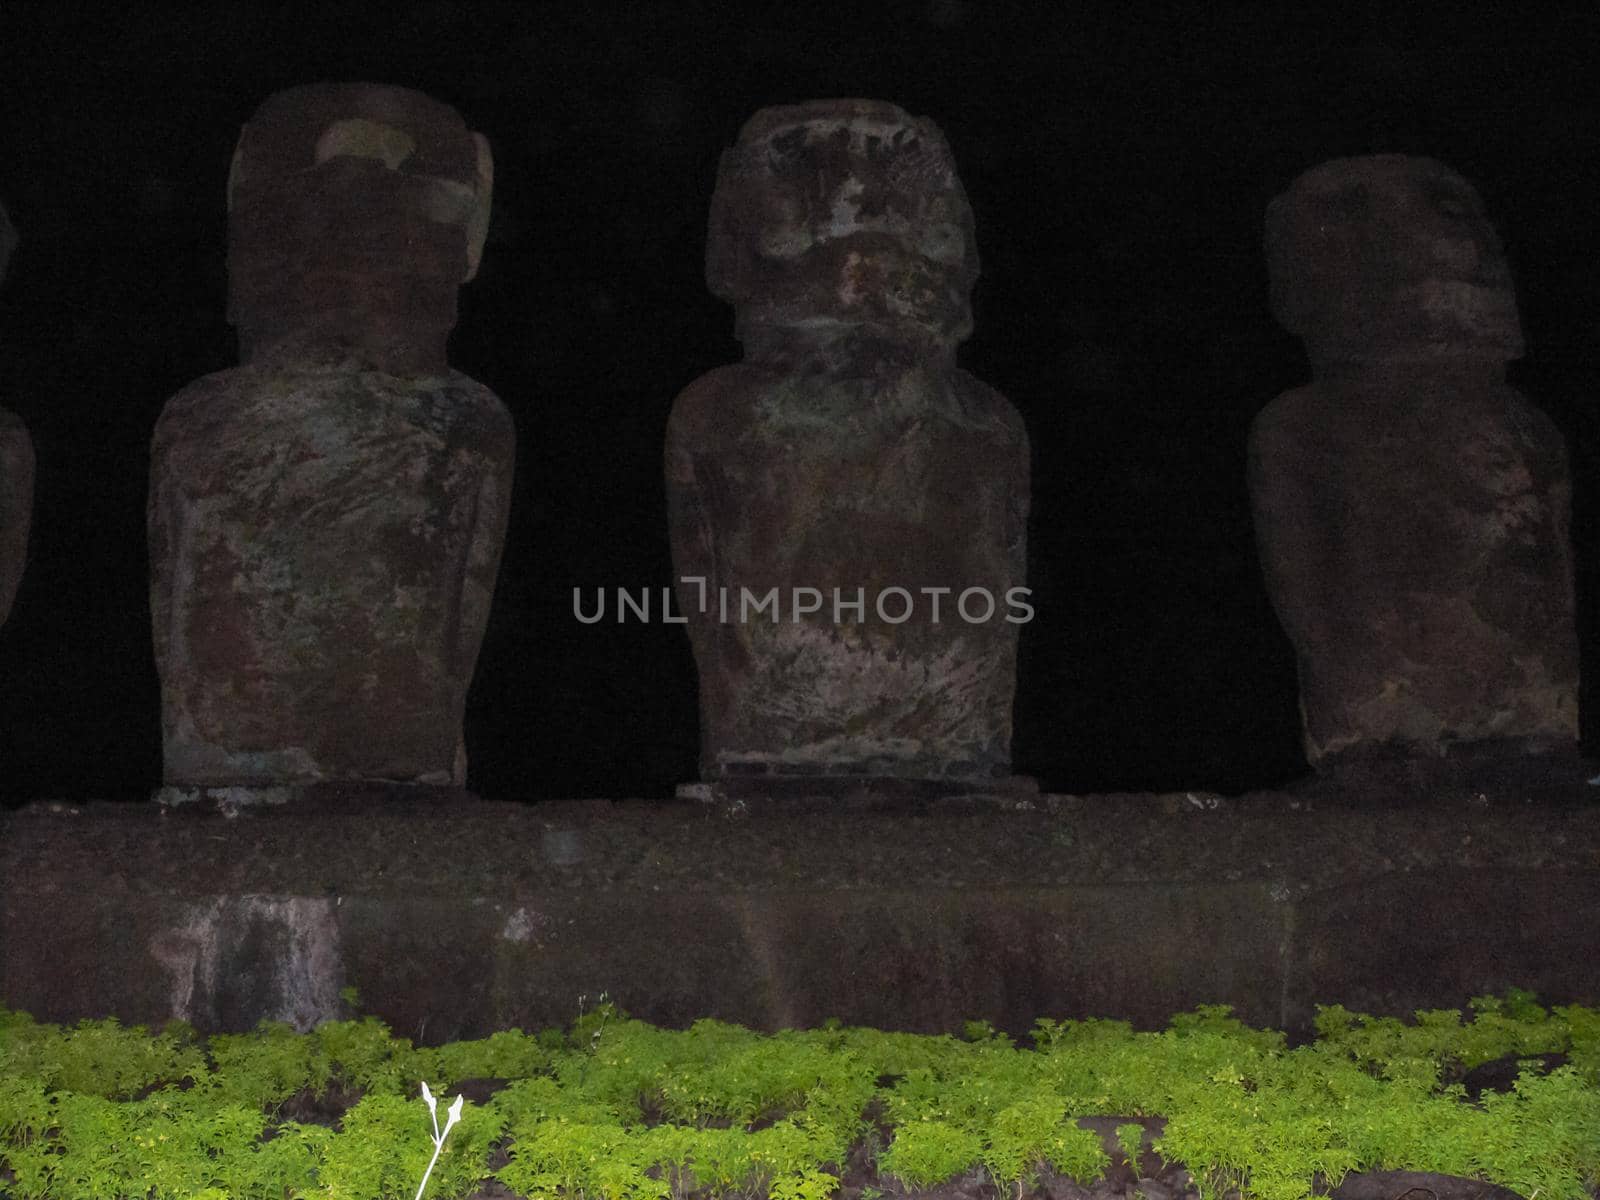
666, 101, 1032, 797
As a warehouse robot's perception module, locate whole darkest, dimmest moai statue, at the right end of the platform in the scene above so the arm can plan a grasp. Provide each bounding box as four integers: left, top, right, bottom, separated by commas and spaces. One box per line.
1250, 154, 1578, 770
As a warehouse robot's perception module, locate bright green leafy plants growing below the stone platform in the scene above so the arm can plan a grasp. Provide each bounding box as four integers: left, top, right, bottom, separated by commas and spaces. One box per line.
0, 992, 1600, 1200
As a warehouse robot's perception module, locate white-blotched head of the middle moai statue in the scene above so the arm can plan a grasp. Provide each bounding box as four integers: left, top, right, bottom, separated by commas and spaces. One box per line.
706, 101, 978, 344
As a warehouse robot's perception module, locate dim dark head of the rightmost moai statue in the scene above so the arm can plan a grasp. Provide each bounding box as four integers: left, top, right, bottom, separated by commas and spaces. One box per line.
1267, 154, 1522, 365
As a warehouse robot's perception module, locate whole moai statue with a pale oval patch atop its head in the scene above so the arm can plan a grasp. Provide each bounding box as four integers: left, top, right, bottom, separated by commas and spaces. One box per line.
149, 83, 514, 802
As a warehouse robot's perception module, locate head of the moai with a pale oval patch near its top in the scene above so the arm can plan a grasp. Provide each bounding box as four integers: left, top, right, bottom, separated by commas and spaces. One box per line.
227, 83, 493, 371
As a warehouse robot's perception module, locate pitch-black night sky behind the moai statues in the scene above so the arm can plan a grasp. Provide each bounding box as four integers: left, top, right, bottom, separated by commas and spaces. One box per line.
0, 0, 1600, 809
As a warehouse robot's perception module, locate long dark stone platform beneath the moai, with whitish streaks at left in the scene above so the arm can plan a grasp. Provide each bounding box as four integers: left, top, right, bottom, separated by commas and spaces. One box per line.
0, 778, 1600, 1043
